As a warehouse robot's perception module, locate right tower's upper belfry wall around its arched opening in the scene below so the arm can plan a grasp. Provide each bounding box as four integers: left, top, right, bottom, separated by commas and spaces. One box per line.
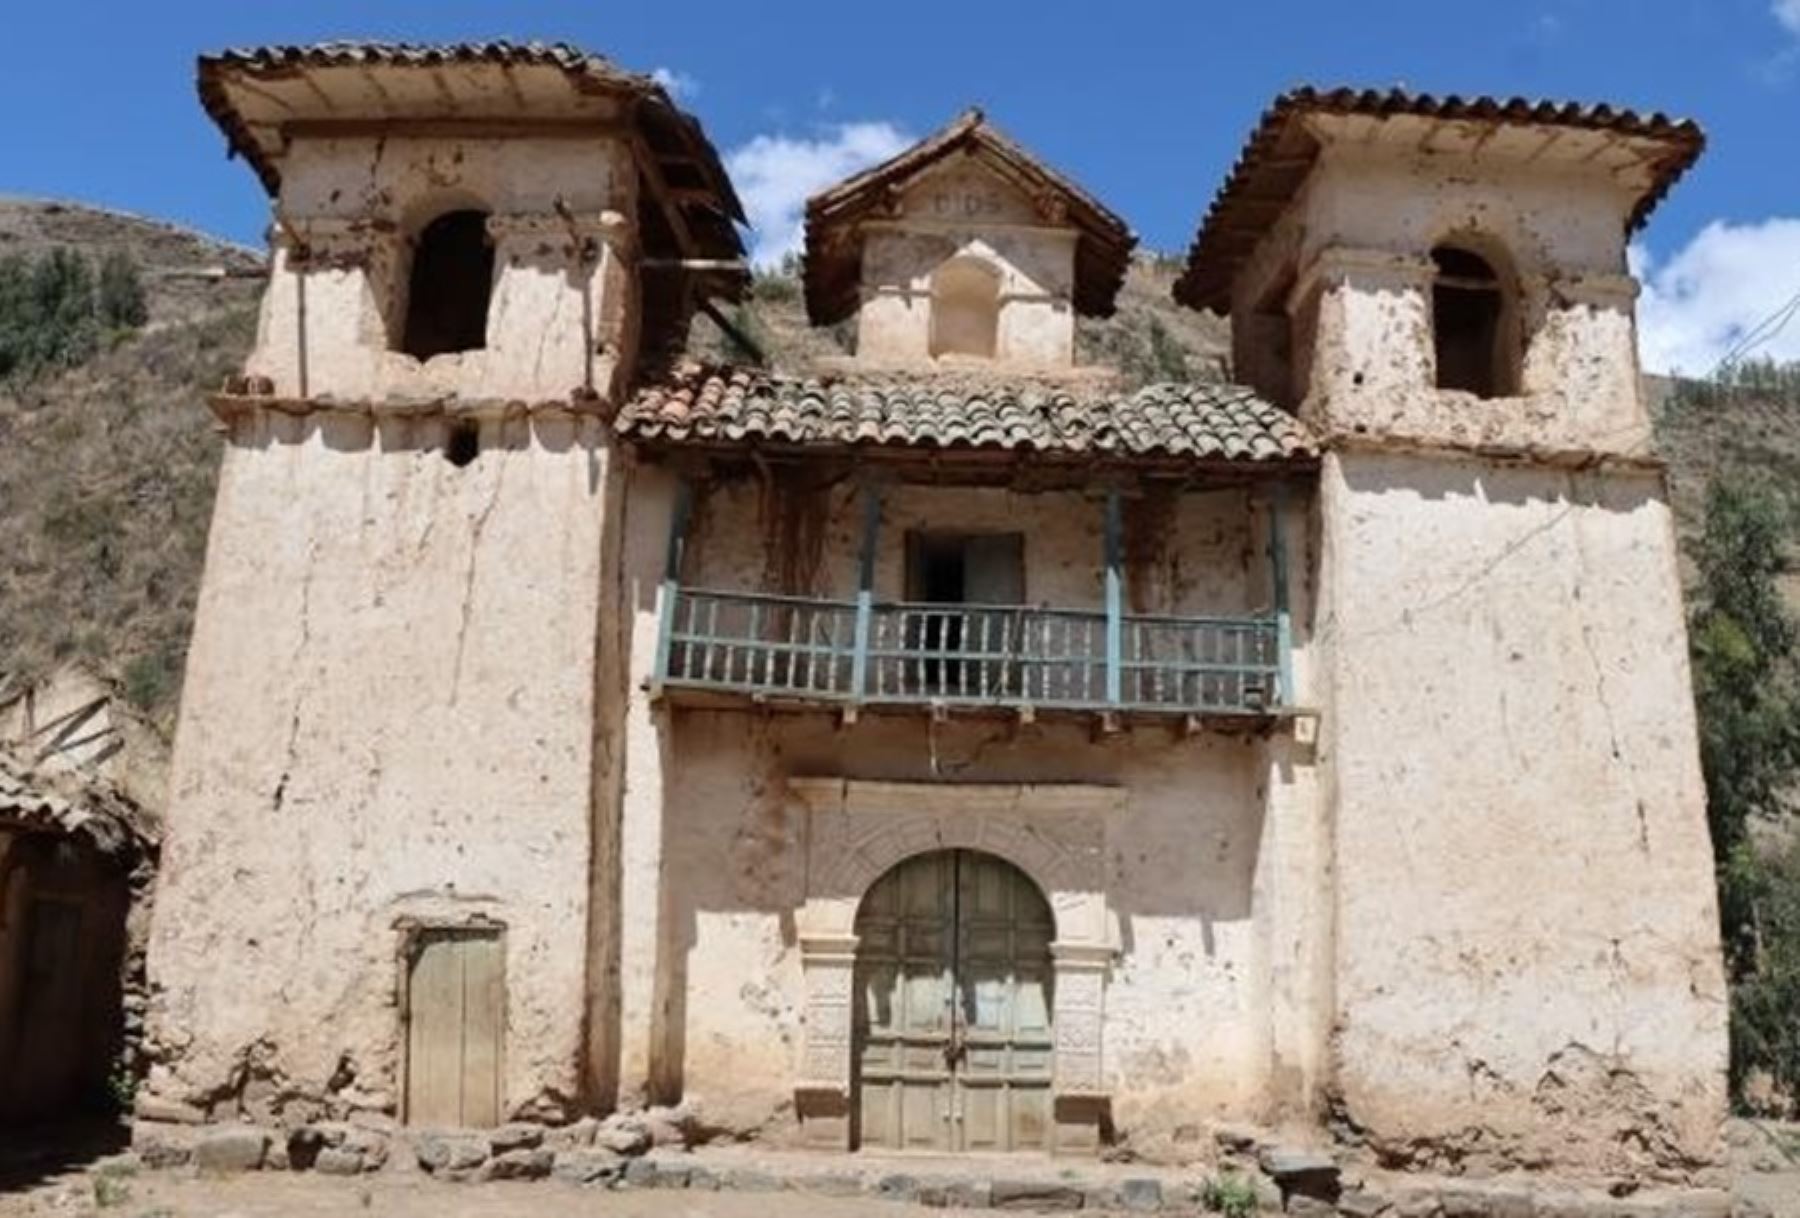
1233, 142, 1651, 459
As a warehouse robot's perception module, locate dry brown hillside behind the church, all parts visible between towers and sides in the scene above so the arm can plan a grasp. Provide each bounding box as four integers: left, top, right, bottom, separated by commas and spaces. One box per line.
0, 198, 1800, 741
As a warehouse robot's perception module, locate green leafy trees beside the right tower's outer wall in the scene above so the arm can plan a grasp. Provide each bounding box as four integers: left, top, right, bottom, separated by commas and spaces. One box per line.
1690, 480, 1800, 1099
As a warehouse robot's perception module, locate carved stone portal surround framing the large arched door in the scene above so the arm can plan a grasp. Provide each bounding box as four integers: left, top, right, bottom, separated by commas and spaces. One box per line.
788, 777, 1125, 1146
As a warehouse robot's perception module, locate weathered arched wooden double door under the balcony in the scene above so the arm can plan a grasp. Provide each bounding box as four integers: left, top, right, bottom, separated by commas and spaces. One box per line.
853, 849, 1055, 1151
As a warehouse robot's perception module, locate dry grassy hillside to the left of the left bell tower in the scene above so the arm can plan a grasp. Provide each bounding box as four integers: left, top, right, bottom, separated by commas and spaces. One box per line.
0, 200, 261, 730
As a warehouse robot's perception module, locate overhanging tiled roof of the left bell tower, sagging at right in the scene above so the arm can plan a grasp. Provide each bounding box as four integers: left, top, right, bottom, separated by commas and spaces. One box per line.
196, 41, 743, 259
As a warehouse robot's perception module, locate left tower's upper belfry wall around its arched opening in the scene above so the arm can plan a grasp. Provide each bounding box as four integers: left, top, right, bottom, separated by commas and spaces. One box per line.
245, 135, 637, 401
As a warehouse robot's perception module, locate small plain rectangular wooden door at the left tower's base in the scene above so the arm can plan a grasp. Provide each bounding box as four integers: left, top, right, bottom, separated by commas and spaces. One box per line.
407, 928, 506, 1128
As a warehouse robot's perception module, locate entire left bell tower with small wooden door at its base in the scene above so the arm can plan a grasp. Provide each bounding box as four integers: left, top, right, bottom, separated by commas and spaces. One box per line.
146, 43, 747, 1124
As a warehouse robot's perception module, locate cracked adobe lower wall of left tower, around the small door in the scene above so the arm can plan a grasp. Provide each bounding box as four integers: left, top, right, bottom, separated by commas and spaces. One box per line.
146, 410, 612, 1119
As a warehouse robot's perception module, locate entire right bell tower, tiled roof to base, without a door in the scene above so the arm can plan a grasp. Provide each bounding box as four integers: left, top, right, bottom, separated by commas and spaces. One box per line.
1175, 88, 1726, 1178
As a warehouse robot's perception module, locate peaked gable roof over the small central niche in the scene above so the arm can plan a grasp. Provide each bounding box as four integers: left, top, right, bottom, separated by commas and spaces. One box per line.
806, 108, 1138, 326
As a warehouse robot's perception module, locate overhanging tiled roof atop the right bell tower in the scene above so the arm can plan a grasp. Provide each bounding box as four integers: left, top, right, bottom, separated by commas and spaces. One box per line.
1175, 86, 1706, 311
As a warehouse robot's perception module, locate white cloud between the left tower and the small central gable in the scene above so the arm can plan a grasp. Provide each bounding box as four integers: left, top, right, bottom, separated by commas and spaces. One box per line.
725, 122, 913, 266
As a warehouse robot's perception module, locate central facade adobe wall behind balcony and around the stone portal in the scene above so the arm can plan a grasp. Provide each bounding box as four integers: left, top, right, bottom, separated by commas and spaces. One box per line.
623, 471, 1328, 1159
